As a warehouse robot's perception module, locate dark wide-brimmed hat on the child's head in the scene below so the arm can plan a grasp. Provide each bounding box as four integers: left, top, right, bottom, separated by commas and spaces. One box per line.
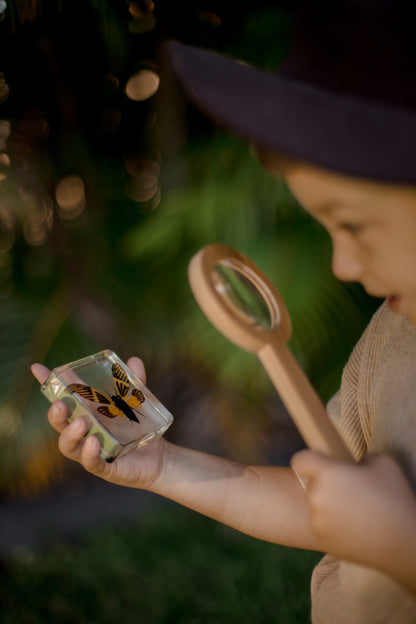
168, 0, 416, 183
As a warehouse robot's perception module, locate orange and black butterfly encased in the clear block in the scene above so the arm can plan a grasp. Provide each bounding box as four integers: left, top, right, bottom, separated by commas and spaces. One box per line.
68, 364, 145, 423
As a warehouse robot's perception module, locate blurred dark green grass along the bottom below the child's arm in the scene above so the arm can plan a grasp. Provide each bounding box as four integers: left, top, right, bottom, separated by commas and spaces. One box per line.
0, 506, 320, 624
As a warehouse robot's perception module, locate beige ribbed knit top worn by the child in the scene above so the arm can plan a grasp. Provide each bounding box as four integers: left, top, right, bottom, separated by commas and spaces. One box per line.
311, 304, 416, 624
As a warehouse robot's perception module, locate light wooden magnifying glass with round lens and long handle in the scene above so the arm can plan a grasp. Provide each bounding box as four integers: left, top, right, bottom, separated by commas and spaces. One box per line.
188, 244, 352, 461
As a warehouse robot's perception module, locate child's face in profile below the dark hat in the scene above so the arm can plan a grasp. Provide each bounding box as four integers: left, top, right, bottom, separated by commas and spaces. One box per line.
261, 154, 416, 328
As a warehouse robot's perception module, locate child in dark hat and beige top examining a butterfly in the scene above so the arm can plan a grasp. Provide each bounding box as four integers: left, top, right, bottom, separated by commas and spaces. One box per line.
32, 0, 416, 624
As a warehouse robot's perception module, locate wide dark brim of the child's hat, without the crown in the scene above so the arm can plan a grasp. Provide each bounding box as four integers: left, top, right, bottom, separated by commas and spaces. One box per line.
167, 41, 416, 183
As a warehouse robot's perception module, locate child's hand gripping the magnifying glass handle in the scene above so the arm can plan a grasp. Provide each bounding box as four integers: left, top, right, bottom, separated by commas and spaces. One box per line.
292, 451, 416, 591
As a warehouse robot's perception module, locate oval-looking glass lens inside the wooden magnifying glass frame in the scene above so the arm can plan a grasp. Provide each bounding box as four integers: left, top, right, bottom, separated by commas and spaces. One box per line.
212, 261, 277, 331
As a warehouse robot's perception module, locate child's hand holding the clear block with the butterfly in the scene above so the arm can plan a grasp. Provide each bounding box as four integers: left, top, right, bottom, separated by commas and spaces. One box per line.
32, 358, 165, 489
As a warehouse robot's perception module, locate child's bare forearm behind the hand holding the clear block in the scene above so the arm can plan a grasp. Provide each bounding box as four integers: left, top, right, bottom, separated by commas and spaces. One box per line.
151, 444, 316, 549
